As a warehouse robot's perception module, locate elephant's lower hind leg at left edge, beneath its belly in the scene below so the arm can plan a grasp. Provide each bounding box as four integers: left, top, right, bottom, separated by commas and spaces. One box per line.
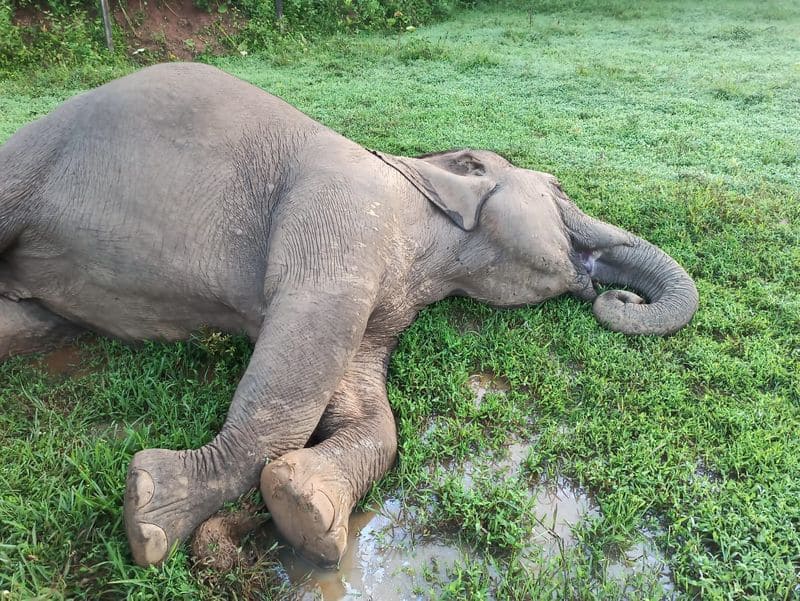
0, 297, 83, 361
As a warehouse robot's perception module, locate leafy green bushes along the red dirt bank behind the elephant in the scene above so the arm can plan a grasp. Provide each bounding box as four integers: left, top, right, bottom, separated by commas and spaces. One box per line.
0, 0, 474, 75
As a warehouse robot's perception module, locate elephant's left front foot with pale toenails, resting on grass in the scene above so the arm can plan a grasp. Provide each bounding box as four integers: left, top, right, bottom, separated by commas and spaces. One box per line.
125, 449, 221, 567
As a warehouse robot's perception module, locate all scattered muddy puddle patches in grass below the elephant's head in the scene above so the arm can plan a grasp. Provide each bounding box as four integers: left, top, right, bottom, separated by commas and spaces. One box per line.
268, 374, 673, 601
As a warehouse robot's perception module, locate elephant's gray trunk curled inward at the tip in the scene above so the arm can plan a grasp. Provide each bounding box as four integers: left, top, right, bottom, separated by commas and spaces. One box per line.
562, 201, 699, 335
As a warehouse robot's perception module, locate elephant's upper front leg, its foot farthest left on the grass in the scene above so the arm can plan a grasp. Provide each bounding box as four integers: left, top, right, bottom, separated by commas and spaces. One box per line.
125, 290, 378, 566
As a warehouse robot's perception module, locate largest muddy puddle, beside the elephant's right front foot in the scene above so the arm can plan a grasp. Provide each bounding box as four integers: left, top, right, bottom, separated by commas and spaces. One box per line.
270, 499, 467, 601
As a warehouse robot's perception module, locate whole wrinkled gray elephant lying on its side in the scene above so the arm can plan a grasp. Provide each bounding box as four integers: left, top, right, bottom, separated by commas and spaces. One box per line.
0, 64, 698, 565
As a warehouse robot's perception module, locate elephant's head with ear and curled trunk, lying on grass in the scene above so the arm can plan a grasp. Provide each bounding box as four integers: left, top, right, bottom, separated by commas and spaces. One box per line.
375, 150, 698, 335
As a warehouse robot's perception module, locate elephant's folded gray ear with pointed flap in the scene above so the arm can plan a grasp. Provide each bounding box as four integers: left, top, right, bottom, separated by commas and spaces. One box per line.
372, 150, 497, 232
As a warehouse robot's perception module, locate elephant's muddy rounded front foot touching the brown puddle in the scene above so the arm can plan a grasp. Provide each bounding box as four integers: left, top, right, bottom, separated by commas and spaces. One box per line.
261, 449, 353, 568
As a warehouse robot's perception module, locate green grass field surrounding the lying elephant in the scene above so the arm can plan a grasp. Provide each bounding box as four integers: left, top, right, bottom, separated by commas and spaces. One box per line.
0, 0, 800, 600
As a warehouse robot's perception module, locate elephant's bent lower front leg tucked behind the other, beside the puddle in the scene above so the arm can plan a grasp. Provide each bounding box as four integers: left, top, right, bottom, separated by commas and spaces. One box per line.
261, 343, 397, 567
